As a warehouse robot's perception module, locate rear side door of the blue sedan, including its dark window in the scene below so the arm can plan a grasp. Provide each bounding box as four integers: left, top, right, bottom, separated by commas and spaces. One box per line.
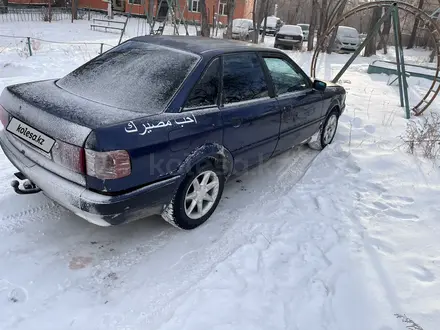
220, 52, 280, 172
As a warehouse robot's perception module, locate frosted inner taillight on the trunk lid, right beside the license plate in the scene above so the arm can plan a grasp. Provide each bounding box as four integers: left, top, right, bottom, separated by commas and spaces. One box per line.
52, 141, 85, 174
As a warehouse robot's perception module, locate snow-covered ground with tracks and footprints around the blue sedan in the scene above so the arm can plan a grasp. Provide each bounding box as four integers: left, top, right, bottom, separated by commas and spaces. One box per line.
0, 18, 440, 330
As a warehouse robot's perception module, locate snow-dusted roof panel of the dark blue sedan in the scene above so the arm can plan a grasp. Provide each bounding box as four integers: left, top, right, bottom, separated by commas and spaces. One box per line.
130, 36, 281, 56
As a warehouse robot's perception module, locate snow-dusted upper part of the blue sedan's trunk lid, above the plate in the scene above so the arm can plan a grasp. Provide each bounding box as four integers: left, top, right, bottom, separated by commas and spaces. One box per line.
0, 80, 145, 147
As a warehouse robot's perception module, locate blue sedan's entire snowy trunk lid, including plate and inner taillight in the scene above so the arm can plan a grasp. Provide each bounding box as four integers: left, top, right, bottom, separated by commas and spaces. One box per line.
0, 80, 145, 185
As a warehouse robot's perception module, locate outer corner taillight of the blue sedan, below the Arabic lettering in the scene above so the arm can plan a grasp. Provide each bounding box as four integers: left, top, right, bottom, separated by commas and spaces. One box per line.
86, 149, 131, 180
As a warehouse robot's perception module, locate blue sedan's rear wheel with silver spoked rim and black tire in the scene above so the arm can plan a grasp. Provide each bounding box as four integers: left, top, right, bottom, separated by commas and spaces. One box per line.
162, 161, 225, 230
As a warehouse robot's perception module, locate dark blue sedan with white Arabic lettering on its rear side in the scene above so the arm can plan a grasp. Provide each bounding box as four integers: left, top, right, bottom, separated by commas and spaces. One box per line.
0, 36, 345, 229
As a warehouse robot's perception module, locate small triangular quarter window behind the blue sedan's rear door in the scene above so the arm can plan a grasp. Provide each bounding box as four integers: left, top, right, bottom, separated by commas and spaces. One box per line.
185, 59, 220, 108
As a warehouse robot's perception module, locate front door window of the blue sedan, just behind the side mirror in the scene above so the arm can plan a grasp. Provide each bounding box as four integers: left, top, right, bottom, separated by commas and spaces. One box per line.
264, 57, 310, 95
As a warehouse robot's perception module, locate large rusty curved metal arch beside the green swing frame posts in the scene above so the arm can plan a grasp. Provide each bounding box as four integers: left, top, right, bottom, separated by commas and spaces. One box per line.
310, 0, 440, 116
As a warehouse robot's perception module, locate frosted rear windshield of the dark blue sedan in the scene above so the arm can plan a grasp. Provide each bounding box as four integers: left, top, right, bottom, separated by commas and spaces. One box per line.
57, 41, 199, 114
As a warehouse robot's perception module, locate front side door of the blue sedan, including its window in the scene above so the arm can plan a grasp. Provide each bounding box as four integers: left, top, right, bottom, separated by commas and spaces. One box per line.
263, 53, 323, 153
